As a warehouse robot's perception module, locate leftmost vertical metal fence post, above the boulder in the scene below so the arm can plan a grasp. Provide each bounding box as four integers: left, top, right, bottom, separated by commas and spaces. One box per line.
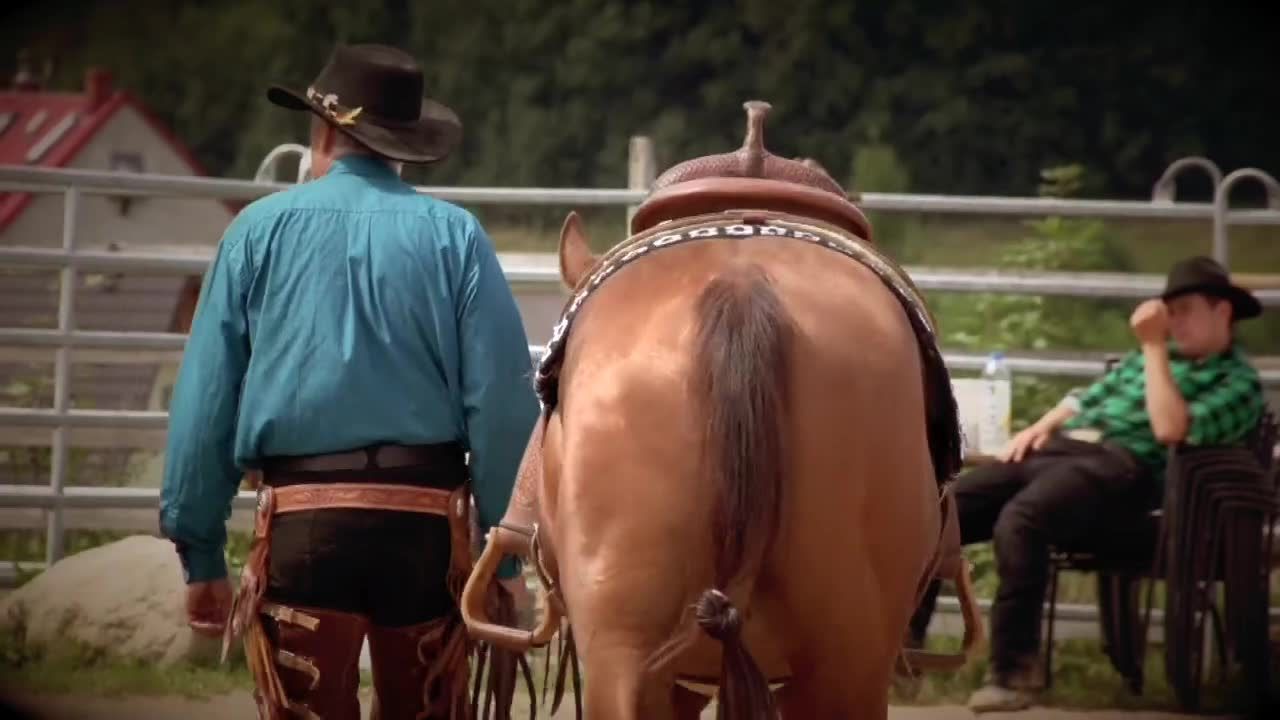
45, 186, 79, 568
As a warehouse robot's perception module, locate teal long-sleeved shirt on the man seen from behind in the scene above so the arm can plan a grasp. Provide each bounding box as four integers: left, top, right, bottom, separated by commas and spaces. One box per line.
160, 156, 538, 582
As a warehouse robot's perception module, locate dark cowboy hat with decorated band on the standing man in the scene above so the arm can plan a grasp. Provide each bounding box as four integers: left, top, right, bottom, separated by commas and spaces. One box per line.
266, 45, 462, 164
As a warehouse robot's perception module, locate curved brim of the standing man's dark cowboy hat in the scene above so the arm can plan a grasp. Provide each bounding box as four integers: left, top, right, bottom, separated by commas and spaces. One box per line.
266, 85, 462, 164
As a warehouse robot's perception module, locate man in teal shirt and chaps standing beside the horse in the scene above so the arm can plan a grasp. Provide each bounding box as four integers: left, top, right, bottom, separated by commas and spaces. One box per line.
160, 46, 538, 717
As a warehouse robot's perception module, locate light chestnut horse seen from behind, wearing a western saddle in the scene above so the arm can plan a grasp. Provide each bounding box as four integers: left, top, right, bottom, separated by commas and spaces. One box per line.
463, 102, 959, 720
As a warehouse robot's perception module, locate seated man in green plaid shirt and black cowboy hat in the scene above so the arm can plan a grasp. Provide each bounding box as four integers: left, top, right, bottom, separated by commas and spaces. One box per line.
910, 258, 1263, 712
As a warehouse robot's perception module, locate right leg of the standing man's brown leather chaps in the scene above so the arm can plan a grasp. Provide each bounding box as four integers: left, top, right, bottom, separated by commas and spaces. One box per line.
369, 616, 471, 720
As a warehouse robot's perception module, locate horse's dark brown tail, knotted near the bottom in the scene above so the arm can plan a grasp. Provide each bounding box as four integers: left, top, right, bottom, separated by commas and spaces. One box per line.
650, 260, 792, 720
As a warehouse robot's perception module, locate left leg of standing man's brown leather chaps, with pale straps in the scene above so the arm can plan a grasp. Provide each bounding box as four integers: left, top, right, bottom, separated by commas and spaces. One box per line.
257, 603, 367, 720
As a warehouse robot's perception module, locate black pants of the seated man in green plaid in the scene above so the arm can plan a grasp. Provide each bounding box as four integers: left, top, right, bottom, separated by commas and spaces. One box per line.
911, 437, 1157, 680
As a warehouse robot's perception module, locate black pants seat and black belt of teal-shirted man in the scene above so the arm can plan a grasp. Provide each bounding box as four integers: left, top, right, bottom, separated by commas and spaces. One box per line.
265, 466, 466, 628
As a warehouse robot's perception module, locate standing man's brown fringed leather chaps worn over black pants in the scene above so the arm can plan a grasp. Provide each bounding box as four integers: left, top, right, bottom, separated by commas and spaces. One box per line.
224, 453, 471, 720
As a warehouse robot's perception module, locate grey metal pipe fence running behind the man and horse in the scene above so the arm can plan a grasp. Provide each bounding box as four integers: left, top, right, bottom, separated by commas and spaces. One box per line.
0, 159, 1280, 573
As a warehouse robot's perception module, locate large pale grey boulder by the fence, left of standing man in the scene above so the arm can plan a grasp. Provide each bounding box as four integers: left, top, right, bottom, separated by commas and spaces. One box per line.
0, 536, 221, 666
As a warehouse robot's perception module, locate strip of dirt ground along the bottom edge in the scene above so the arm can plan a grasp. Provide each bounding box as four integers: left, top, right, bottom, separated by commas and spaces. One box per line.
0, 693, 1239, 720
